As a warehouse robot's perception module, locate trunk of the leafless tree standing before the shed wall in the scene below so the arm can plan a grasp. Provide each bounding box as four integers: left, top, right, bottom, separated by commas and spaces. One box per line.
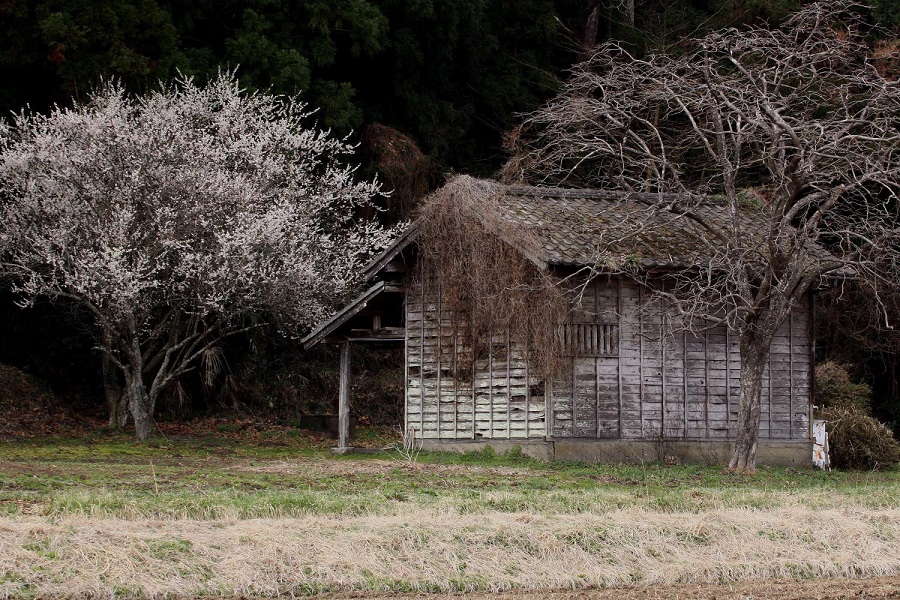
728, 332, 772, 471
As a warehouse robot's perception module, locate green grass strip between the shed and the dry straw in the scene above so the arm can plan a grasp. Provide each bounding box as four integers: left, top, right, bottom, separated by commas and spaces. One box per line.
0, 434, 900, 519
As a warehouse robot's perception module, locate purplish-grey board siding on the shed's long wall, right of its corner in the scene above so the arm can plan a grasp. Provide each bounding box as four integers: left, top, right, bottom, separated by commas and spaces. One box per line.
550, 280, 811, 440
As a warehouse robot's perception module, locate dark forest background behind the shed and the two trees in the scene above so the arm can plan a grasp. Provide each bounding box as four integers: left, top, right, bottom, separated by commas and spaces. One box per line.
0, 0, 900, 432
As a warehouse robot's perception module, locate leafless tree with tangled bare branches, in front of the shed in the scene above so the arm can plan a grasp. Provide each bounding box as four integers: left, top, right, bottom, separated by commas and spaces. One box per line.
505, 2, 900, 469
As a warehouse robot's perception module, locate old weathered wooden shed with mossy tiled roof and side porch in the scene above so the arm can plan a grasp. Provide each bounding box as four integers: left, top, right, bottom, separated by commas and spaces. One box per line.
304, 180, 813, 465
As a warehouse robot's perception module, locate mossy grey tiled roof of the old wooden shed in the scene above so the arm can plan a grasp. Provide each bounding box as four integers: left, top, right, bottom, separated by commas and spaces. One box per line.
365, 176, 836, 279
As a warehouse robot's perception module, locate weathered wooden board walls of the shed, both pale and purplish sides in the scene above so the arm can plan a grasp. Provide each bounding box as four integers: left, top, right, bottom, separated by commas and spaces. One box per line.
406, 279, 811, 440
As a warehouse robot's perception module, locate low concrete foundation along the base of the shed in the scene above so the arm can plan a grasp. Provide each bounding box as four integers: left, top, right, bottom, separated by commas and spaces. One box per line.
422, 439, 813, 468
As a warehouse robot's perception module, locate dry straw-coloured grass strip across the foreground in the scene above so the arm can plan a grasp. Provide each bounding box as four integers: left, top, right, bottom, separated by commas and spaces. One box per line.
0, 507, 900, 598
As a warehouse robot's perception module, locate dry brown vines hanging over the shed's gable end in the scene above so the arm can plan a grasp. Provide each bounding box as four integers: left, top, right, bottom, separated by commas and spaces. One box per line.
417, 176, 569, 376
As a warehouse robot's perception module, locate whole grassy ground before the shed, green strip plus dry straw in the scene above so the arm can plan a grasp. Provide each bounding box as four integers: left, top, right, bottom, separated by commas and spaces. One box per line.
0, 435, 900, 598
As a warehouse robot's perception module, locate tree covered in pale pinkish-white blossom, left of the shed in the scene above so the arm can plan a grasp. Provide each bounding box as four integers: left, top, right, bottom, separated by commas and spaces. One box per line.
0, 75, 390, 440
